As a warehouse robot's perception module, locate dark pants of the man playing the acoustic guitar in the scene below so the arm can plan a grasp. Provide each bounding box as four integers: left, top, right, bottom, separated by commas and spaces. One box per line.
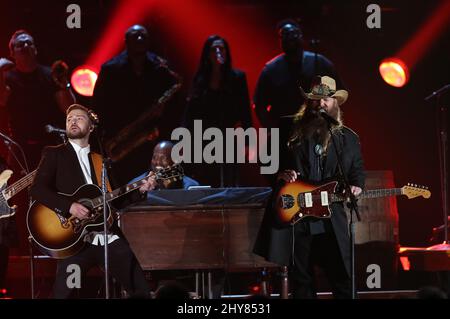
53, 238, 150, 299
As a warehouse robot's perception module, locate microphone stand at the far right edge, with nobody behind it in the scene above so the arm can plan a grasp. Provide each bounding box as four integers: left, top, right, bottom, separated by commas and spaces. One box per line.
425, 84, 450, 250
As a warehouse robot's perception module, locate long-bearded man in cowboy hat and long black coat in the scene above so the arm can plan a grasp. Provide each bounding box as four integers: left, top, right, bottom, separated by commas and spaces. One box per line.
255, 76, 365, 298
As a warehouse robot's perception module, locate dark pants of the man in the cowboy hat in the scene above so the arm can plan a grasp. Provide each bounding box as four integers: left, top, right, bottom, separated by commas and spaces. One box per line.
290, 221, 351, 299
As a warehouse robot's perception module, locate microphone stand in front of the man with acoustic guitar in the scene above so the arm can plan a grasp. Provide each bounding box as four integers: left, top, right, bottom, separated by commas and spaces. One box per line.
96, 130, 110, 299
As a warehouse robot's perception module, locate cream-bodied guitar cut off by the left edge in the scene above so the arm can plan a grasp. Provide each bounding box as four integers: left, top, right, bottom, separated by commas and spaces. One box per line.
0, 169, 36, 219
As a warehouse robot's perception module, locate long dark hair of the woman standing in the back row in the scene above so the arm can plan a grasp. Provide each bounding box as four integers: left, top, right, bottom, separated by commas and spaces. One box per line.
189, 35, 233, 98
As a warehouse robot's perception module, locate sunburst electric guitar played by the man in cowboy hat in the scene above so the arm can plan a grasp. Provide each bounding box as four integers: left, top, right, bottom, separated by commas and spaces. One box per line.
273, 181, 431, 225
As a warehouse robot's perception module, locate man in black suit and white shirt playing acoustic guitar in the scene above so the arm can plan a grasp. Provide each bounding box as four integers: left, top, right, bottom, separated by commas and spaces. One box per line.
31, 104, 156, 298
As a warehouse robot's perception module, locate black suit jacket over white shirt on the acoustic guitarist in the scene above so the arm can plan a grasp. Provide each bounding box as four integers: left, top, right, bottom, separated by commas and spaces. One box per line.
30, 143, 103, 216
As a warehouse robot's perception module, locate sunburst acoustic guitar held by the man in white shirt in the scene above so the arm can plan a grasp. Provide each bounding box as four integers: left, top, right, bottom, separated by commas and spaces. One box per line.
26, 165, 184, 258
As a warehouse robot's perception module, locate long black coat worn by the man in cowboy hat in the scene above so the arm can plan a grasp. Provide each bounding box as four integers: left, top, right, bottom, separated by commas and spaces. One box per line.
254, 127, 365, 271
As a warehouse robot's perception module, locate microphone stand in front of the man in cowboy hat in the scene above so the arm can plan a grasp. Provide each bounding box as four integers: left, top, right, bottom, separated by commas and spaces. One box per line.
328, 122, 361, 299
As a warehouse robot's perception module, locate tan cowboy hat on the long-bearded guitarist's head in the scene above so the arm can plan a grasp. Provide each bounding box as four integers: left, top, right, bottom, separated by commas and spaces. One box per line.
300, 76, 348, 105
